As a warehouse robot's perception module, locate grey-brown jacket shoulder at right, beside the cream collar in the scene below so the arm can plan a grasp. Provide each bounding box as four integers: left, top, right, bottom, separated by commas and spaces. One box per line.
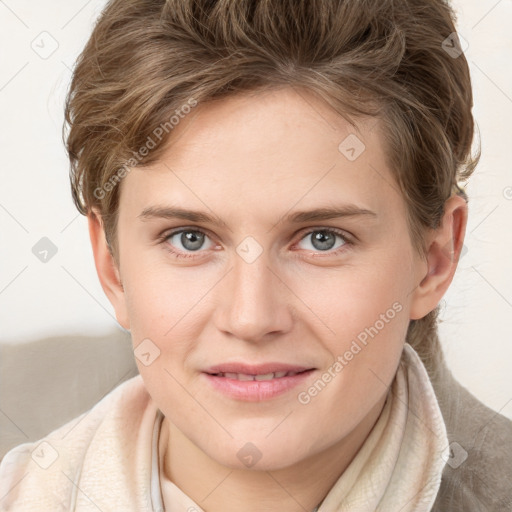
432, 363, 512, 512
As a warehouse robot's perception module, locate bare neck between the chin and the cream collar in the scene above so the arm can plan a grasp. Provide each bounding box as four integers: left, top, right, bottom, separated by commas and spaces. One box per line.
160, 394, 386, 512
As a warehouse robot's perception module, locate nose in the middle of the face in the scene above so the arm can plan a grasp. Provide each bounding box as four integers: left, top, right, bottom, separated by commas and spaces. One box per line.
216, 251, 293, 342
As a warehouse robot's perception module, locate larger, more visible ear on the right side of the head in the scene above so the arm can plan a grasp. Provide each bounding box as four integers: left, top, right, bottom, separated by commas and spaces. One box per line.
410, 195, 468, 320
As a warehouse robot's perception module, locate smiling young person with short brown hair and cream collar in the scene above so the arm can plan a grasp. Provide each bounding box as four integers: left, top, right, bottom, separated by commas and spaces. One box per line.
0, 0, 512, 512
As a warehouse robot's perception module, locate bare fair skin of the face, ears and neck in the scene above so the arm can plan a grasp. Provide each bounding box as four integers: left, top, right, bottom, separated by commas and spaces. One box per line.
89, 88, 467, 512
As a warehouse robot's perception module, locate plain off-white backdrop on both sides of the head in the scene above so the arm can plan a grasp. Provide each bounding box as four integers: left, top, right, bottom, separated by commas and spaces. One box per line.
0, 0, 512, 419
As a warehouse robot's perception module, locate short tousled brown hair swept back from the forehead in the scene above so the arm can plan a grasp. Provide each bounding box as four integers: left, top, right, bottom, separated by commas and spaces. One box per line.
63, 0, 480, 378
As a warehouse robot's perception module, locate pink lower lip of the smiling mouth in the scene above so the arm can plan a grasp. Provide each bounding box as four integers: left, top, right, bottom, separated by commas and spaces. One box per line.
203, 370, 314, 402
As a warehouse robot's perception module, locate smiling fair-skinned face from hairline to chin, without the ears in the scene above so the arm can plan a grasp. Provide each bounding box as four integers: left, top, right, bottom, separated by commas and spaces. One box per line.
108, 89, 428, 469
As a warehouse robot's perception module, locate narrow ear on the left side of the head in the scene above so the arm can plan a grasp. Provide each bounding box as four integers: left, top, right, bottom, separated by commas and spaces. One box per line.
87, 210, 130, 330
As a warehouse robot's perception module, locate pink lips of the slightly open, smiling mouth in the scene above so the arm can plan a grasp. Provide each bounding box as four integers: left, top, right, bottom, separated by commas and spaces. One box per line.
203, 363, 315, 402
